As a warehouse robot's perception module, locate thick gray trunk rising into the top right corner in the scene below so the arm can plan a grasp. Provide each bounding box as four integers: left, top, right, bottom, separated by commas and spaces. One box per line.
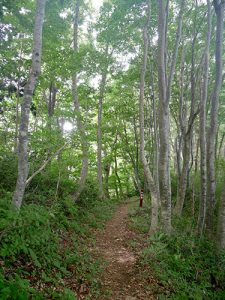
206, 0, 225, 233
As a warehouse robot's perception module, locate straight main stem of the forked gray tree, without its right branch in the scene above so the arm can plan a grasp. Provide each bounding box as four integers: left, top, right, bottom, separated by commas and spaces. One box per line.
158, 0, 171, 234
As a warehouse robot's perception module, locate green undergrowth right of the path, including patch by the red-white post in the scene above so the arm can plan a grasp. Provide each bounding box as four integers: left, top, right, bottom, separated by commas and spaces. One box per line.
130, 198, 225, 300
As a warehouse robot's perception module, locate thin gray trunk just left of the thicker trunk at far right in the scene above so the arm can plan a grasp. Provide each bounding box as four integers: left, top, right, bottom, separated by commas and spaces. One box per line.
198, 0, 212, 236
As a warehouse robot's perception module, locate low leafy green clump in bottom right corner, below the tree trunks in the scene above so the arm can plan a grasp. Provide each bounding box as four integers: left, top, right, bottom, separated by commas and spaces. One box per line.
142, 234, 225, 299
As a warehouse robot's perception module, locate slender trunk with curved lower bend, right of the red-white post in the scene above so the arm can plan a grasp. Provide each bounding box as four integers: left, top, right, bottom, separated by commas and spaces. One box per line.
139, 1, 158, 234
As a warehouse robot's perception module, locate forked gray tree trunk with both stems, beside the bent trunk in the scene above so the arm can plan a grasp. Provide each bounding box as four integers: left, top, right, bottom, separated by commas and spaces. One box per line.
158, 0, 185, 227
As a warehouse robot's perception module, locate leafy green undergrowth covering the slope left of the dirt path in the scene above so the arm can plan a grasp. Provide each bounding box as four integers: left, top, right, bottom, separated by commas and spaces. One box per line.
0, 171, 119, 300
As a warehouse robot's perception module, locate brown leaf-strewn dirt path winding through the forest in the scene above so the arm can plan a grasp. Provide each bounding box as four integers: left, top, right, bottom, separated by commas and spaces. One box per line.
94, 199, 156, 300
